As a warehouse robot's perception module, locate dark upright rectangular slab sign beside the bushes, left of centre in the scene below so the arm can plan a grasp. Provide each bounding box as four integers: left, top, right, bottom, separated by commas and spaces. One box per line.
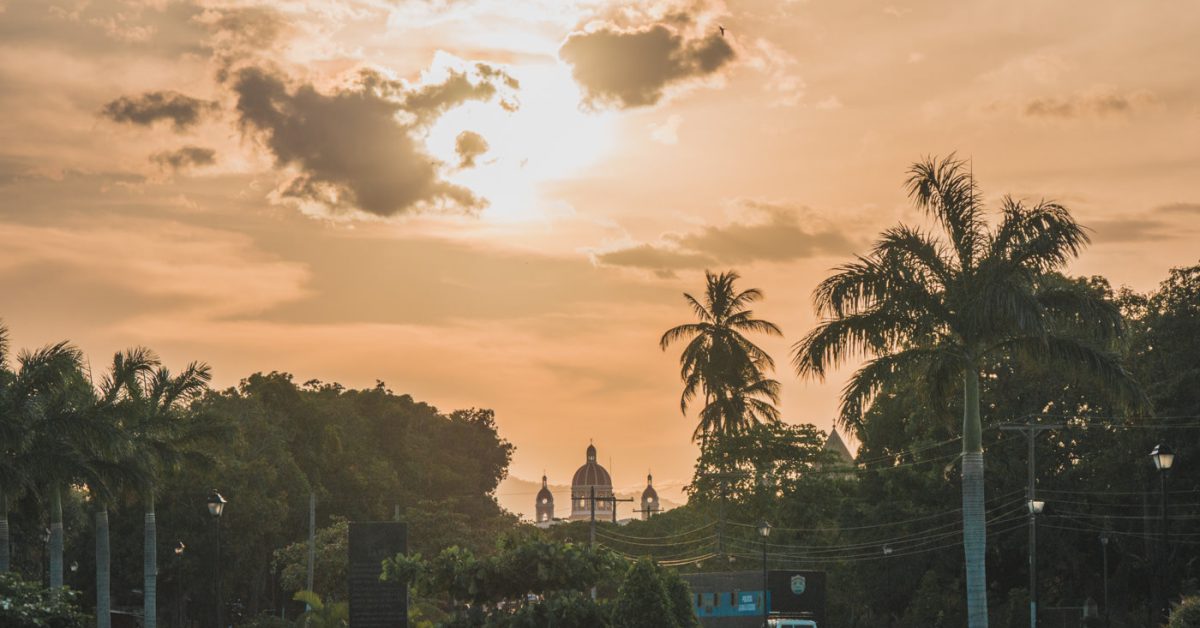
349, 521, 408, 628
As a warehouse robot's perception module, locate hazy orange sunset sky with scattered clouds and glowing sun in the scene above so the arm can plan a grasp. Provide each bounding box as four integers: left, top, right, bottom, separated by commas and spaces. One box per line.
0, 0, 1200, 511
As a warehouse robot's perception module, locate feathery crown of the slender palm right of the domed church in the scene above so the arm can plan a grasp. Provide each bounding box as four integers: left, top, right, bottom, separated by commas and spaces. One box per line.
659, 270, 782, 439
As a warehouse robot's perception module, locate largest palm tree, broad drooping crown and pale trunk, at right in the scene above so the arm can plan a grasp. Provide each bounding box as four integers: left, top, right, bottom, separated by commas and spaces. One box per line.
793, 155, 1140, 628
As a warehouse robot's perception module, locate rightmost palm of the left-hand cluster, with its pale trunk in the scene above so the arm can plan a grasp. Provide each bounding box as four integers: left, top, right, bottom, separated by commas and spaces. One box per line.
97, 347, 212, 628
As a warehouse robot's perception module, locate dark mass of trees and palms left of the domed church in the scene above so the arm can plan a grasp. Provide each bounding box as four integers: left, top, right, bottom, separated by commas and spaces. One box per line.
0, 355, 515, 626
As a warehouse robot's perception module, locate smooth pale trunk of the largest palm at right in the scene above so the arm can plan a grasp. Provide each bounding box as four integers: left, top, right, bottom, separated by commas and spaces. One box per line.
962, 365, 988, 628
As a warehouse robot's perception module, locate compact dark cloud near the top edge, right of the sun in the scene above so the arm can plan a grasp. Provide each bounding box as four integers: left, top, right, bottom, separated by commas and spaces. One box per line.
558, 20, 733, 107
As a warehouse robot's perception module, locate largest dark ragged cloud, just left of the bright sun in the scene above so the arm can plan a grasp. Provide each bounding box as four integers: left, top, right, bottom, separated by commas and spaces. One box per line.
233, 66, 516, 216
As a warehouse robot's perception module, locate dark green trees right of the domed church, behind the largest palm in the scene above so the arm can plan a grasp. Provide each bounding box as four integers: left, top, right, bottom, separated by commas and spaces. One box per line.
590, 265, 1200, 628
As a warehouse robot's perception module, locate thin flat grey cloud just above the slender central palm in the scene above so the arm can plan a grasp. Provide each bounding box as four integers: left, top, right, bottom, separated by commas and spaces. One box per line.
595, 201, 853, 276
